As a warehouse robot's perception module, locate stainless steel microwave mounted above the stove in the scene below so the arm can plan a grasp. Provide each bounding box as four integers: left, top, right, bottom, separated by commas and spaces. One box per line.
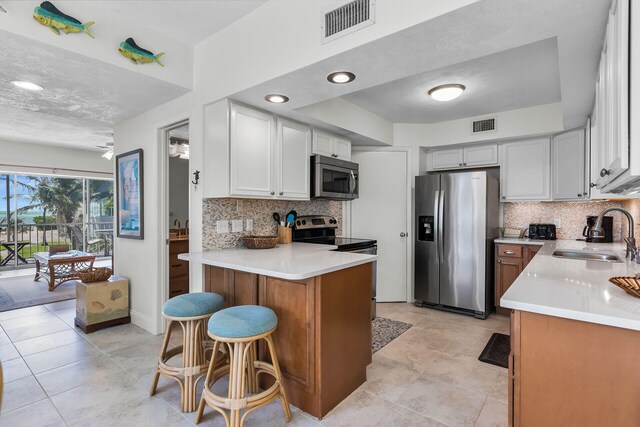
311, 154, 358, 200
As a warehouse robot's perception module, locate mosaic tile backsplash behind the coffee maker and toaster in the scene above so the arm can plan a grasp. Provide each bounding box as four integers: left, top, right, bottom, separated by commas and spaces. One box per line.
503, 199, 640, 241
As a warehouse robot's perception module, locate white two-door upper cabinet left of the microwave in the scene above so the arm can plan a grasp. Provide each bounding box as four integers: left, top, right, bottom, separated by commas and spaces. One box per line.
202, 100, 311, 200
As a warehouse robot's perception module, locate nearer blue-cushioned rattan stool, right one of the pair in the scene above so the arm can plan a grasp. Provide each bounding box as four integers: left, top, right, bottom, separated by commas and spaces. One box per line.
196, 305, 291, 427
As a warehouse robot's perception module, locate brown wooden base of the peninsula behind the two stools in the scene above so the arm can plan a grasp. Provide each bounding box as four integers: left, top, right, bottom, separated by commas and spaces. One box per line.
205, 264, 372, 418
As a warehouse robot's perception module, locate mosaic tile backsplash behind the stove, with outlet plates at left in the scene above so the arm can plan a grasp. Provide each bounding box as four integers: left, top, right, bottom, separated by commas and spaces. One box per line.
202, 199, 342, 251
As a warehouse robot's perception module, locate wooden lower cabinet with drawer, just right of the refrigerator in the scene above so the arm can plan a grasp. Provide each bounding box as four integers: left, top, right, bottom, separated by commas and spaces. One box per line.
494, 243, 542, 315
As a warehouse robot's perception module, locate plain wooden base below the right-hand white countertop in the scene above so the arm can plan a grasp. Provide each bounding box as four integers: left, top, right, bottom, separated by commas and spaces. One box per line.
509, 311, 640, 427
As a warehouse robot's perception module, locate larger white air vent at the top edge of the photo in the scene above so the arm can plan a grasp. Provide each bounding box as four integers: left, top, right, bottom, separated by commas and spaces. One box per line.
322, 0, 375, 43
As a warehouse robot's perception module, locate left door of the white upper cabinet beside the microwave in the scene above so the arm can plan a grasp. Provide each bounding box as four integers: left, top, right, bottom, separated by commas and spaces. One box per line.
230, 104, 275, 197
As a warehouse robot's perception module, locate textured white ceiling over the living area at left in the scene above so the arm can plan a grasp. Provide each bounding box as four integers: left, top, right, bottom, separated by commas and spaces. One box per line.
0, 30, 187, 148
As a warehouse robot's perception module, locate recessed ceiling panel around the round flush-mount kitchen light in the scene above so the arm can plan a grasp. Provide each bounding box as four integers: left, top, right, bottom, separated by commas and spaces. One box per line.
344, 38, 561, 123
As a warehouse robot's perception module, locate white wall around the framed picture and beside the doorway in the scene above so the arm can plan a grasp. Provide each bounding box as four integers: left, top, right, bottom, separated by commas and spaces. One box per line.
114, 94, 192, 334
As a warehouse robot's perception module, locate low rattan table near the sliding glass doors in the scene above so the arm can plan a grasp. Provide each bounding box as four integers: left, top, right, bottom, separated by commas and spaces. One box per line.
33, 251, 96, 291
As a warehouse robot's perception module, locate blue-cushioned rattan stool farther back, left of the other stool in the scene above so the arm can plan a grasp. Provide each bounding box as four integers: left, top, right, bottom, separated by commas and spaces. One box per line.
150, 292, 224, 412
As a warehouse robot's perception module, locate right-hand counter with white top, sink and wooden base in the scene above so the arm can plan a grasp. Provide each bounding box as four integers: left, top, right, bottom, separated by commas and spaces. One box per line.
500, 240, 640, 426
